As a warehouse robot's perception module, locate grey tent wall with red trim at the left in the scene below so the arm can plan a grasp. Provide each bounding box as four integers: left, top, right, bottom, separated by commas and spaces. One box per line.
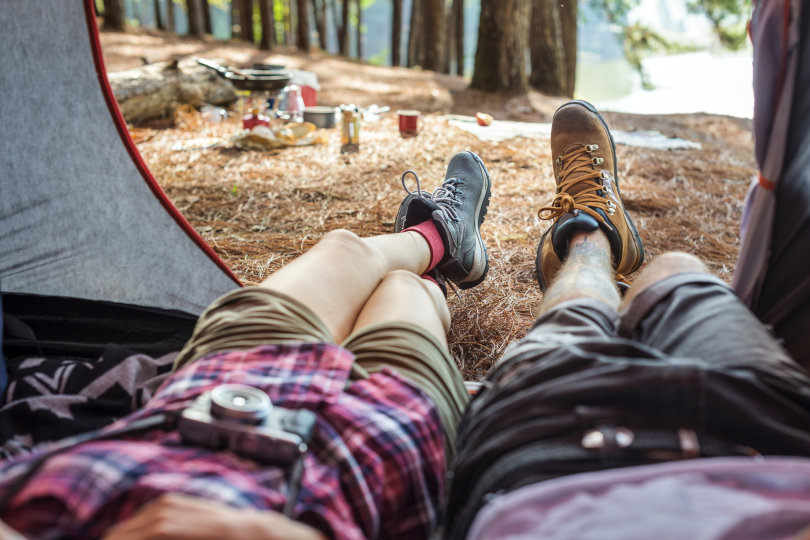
0, 0, 239, 314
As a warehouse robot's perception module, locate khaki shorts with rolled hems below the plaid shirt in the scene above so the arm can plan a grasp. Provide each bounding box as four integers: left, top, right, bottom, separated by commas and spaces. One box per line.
174, 287, 468, 459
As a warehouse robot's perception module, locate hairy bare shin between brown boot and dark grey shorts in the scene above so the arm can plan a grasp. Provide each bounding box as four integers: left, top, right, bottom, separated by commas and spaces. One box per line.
540, 230, 620, 314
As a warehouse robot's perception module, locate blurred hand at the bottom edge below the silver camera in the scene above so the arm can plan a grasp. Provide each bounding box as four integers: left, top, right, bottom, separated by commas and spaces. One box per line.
104, 493, 326, 540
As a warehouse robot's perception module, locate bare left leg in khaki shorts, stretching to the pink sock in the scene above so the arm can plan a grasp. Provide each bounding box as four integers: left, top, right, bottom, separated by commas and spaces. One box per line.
261, 230, 430, 343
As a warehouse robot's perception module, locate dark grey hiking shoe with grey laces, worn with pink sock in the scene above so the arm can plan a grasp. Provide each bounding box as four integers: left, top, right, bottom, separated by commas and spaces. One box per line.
394, 151, 491, 289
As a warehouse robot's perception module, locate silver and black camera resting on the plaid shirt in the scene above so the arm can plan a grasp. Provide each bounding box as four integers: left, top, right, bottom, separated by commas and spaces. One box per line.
177, 384, 316, 465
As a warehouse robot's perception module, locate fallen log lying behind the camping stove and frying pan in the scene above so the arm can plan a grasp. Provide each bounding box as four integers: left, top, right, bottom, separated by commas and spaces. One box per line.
108, 60, 237, 124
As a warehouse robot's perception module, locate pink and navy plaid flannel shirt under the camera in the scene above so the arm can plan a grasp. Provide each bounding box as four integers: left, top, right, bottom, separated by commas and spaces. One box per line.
0, 344, 445, 540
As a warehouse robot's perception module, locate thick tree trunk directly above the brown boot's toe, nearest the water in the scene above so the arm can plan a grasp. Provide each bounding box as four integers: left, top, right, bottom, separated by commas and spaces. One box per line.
529, 0, 577, 97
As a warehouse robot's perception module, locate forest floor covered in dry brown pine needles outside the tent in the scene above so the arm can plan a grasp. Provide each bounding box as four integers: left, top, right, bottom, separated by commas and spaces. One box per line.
101, 25, 756, 380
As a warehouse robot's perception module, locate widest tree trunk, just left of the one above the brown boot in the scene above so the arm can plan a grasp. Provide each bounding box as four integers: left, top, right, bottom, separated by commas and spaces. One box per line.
470, 0, 531, 94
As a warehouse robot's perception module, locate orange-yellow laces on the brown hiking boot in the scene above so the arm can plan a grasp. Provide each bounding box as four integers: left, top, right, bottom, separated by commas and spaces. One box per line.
537, 144, 612, 230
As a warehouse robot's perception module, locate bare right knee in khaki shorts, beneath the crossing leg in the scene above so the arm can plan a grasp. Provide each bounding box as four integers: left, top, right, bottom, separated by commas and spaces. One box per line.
352, 270, 450, 346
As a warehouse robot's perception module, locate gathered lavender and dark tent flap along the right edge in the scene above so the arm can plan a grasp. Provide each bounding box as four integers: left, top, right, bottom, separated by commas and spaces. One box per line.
732, 0, 810, 368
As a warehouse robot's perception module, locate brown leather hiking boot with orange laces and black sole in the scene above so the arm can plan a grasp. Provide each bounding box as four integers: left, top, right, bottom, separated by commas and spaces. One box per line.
535, 101, 644, 290
